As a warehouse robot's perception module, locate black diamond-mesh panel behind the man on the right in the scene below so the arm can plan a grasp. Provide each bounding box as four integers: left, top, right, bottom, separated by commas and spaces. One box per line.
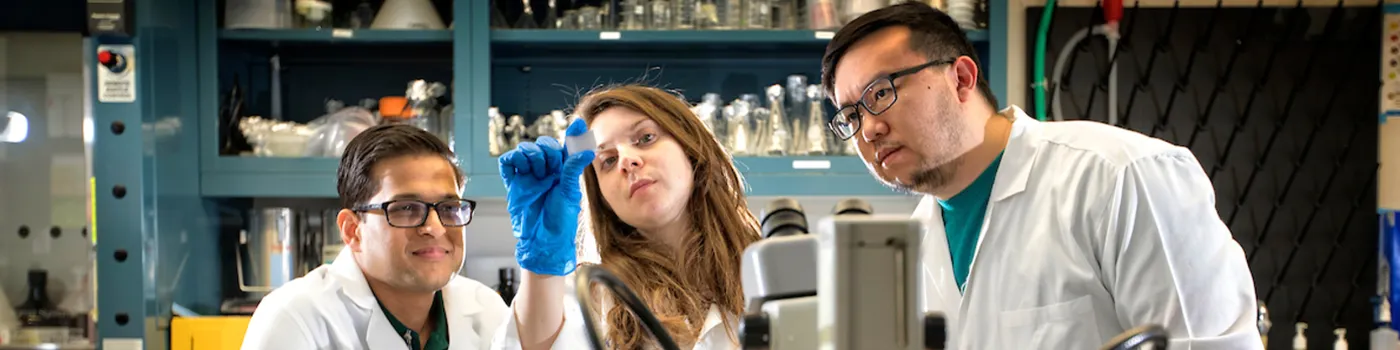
1025, 0, 1380, 349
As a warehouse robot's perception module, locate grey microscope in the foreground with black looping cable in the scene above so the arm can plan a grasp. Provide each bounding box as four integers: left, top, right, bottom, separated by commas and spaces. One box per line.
574, 197, 1168, 350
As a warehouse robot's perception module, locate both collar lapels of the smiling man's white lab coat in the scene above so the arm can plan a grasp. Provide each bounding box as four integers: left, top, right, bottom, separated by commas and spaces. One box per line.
330, 248, 482, 349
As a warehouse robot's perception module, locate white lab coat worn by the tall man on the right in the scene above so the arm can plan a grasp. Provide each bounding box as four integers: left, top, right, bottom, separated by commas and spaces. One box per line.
913, 108, 1263, 350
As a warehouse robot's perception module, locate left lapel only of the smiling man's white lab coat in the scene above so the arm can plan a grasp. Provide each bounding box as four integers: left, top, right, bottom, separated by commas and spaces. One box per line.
330, 249, 409, 350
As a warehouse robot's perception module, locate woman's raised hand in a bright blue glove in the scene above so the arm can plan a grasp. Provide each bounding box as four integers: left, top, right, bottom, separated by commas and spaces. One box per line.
500, 119, 594, 276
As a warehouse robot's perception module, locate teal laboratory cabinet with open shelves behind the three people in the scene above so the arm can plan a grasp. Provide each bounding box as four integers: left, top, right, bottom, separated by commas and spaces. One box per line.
84, 0, 1008, 349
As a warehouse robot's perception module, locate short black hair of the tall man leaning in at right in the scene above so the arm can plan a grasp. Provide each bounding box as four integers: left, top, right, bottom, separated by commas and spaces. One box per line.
822, 1, 1000, 109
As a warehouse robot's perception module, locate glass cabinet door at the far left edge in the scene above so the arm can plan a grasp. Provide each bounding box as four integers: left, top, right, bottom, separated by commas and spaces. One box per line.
0, 32, 95, 346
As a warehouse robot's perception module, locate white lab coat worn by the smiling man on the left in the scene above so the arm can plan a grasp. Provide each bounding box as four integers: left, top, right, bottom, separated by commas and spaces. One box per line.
242, 249, 511, 350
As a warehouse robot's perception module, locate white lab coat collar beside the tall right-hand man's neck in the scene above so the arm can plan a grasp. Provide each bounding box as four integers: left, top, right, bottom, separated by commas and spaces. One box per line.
979, 105, 1042, 203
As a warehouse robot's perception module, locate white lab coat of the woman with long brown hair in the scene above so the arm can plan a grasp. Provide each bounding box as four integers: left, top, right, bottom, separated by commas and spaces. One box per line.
491, 274, 741, 350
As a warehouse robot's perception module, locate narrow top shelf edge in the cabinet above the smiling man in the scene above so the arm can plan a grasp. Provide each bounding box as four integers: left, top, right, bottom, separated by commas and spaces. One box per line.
218, 29, 452, 43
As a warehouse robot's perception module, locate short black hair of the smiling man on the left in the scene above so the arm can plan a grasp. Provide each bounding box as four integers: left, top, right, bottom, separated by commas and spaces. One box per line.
336, 123, 465, 209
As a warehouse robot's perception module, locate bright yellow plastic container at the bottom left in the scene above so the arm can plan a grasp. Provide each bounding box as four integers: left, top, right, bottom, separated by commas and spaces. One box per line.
171, 316, 251, 350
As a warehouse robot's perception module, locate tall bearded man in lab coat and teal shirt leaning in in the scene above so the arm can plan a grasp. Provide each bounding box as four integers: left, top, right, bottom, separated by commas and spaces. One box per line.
822, 1, 1263, 350
